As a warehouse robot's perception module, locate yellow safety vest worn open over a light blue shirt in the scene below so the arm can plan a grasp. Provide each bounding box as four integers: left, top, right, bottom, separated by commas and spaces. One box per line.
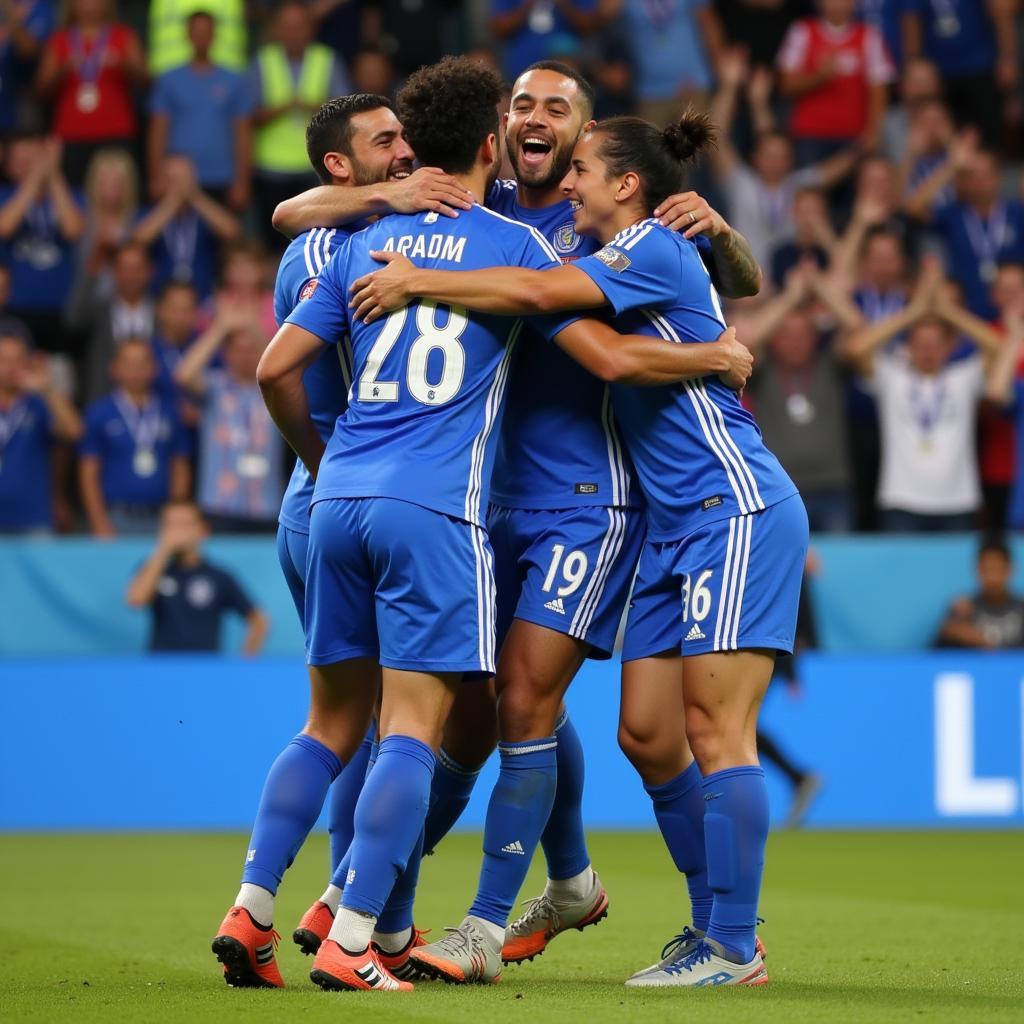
254, 43, 334, 174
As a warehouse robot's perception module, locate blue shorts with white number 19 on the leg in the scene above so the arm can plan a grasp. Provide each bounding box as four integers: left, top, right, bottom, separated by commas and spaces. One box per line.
487, 505, 645, 658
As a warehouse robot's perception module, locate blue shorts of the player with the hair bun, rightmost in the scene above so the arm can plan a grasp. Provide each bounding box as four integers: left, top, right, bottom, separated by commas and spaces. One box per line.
623, 495, 808, 662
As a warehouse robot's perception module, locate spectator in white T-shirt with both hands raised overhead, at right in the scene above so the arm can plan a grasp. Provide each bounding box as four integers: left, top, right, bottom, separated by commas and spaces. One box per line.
847, 268, 999, 532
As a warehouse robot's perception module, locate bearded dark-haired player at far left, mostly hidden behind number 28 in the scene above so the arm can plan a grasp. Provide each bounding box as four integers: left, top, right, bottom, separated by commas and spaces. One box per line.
213, 94, 446, 987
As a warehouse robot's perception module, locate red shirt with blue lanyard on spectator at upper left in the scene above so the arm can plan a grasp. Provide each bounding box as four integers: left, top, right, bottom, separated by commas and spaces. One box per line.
47, 25, 139, 142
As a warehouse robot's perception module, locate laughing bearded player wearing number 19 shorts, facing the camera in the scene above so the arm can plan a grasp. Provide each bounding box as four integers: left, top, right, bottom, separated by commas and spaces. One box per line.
284, 61, 760, 980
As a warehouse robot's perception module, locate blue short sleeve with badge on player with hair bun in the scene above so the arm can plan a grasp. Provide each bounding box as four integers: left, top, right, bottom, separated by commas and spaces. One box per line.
573, 224, 679, 315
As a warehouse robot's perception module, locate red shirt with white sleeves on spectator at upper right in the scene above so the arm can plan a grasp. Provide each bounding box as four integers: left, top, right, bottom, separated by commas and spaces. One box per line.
778, 17, 895, 139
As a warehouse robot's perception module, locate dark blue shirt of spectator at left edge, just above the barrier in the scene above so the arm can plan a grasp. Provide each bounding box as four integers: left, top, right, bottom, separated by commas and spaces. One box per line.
0, 394, 53, 532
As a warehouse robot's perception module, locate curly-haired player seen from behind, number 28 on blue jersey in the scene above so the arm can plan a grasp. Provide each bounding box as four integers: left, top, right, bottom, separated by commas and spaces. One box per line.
259, 58, 753, 990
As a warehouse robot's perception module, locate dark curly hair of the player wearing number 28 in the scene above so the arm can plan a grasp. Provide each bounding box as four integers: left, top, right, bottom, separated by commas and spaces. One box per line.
398, 56, 502, 174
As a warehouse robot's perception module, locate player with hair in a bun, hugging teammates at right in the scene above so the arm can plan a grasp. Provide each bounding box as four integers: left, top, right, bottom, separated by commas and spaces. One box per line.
355, 115, 807, 986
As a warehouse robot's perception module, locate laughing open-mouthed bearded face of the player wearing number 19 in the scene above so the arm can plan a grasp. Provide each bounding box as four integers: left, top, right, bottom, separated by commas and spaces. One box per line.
505, 71, 585, 188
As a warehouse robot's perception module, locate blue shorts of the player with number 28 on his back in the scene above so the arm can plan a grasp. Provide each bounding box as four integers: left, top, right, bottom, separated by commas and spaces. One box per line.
305, 498, 495, 674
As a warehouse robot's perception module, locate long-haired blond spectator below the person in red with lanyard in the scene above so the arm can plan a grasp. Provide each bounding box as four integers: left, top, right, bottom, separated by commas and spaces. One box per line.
75, 148, 138, 297
